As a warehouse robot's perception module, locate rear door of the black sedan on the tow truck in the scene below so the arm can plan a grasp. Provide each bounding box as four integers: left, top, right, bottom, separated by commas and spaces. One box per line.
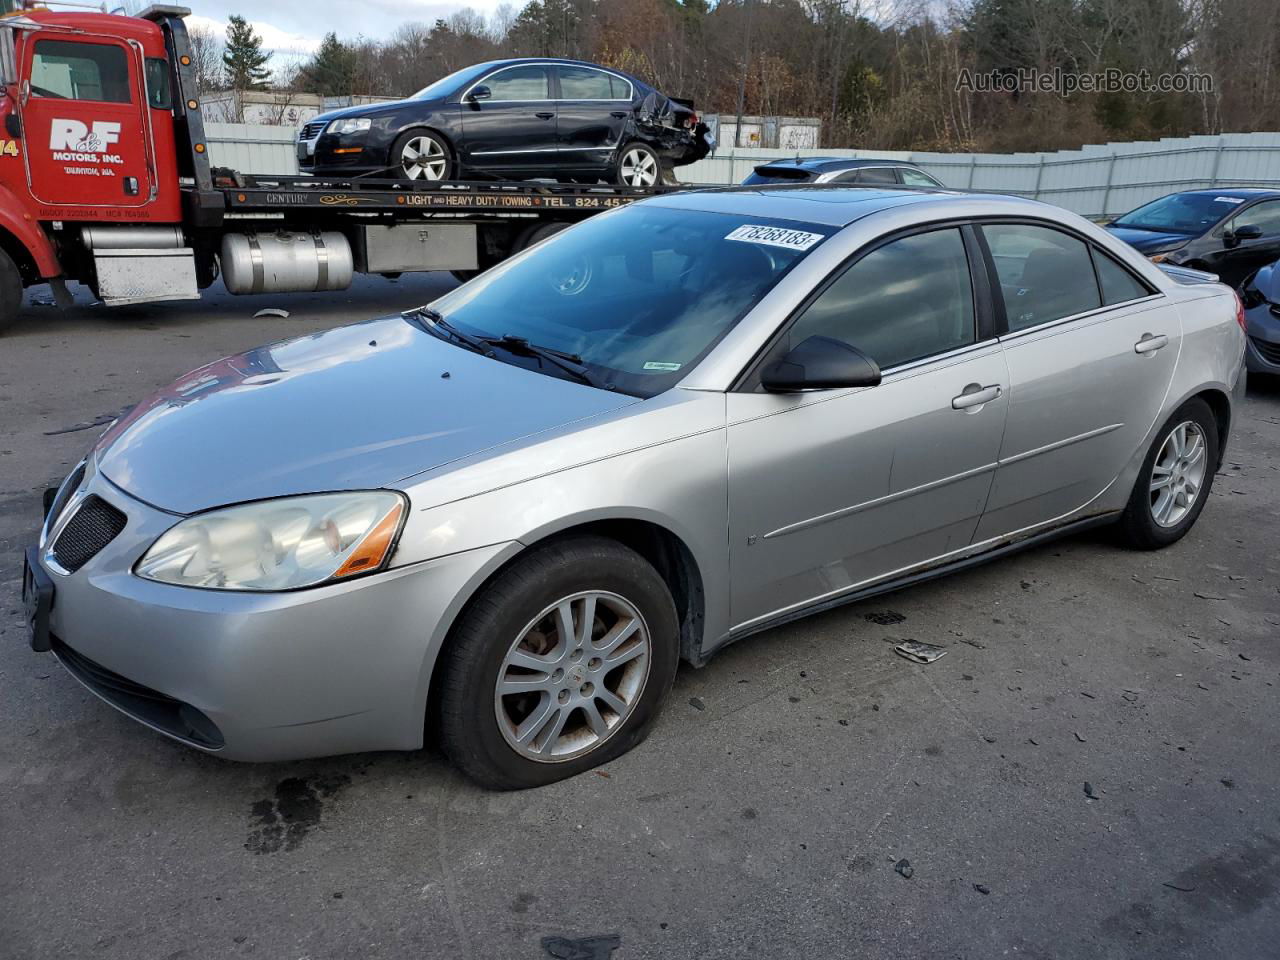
556, 64, 635, 170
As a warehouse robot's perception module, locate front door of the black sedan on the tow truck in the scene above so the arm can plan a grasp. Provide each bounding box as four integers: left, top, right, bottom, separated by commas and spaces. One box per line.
458, 64, 557, 174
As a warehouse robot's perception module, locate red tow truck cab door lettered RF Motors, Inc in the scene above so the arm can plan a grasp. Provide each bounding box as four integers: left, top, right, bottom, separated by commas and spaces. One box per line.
22, 33, 154, 207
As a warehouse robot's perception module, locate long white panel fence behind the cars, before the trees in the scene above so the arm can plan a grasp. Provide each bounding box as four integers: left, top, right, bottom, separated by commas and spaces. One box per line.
207, 123, 1280, 218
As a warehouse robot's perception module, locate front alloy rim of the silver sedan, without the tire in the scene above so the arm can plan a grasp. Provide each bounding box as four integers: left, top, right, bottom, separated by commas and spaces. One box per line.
494, 590, 650, 762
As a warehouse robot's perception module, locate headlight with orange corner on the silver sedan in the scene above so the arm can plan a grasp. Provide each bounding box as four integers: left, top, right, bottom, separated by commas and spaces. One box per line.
134, 490, 406, 590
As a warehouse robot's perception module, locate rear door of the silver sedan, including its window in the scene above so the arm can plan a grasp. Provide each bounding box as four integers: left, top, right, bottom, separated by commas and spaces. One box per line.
977, 224, 1181, 541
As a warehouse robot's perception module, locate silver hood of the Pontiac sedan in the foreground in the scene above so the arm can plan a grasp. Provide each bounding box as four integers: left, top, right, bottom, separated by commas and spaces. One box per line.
95, 316, 636, 513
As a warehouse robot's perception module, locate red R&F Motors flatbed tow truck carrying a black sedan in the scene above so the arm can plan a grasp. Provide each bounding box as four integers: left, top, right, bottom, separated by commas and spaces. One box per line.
0, 5, 663, 329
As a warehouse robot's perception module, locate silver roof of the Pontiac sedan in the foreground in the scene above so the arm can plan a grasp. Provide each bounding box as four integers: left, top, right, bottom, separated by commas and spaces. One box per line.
641, 183, 983, 227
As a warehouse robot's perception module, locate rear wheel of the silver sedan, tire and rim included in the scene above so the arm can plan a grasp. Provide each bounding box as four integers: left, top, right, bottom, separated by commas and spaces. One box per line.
1117, 398, 1219, 550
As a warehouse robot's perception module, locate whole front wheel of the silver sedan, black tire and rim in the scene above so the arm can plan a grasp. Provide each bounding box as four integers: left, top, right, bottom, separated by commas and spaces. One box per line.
436, 536, 680, 790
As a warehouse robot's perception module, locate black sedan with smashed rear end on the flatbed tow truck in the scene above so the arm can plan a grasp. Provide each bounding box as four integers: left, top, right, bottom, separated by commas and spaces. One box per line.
297, 59, 710, 187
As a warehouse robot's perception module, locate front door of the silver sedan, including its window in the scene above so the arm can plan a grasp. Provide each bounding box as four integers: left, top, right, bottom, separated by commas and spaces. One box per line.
728, 228, 1007, 628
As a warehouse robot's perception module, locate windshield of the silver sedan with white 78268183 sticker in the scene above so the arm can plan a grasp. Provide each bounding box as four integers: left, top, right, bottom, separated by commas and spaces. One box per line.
431, 204, 832, 397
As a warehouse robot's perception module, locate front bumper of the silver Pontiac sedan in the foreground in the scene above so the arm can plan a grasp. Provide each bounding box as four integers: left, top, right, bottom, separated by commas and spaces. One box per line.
31, 475, 504, 760
